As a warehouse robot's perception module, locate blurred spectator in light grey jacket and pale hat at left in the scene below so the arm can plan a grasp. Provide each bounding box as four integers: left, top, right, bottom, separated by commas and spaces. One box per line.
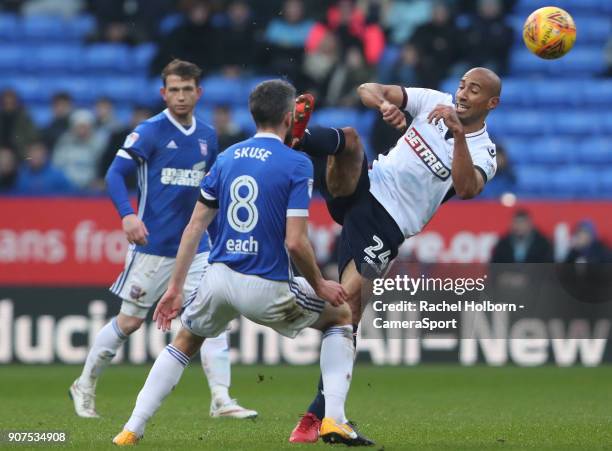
53, 110, 108, 189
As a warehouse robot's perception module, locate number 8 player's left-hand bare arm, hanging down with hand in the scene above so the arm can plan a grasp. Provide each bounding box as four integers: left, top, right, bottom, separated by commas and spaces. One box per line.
153, 202, 218, 331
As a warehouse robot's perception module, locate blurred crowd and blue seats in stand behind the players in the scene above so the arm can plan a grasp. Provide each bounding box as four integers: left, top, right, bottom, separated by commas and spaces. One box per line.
0, 0, 612, 199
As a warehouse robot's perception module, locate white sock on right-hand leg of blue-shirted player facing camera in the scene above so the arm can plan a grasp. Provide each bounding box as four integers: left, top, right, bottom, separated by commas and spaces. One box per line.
200, 332, 231, 405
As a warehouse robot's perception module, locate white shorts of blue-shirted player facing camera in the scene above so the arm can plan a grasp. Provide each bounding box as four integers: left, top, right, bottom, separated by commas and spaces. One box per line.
110, 249, 208, 318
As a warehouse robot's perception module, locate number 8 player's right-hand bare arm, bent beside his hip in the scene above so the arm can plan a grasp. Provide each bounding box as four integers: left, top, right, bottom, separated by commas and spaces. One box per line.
285, 216, 347, 306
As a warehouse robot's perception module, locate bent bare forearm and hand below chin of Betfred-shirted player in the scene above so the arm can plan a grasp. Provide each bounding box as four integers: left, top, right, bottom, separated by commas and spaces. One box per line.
428, 105, 485, 199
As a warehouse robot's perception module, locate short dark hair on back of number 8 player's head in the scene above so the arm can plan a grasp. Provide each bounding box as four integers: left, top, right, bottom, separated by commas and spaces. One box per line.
249, 80, 295, 127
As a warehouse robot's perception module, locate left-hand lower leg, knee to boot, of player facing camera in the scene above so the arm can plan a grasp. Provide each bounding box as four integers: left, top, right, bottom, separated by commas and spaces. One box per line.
69, 313, 143, 418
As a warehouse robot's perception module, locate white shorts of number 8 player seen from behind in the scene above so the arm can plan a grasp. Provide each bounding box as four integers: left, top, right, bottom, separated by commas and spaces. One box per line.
181, 263, 325, 338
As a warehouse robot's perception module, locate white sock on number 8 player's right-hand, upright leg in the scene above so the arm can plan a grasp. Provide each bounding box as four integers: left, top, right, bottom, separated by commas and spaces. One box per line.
321, 326, 354, 423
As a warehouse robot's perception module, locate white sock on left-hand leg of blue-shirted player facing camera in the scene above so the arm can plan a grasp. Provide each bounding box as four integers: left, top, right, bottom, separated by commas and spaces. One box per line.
79, 317, 128, 391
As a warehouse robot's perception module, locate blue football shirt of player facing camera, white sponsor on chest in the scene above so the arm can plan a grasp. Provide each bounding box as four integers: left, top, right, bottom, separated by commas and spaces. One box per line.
122, 109, 218, 257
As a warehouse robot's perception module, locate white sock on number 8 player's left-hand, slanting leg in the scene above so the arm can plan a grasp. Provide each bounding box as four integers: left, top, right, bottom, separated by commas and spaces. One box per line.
124, 345, 189, 436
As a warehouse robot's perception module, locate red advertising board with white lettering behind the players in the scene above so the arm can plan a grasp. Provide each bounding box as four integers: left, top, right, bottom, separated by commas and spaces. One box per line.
0, 198, 612, 286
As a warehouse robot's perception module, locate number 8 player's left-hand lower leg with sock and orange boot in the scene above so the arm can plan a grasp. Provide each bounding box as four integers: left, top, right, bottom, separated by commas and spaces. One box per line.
113, 328, 204, 446
